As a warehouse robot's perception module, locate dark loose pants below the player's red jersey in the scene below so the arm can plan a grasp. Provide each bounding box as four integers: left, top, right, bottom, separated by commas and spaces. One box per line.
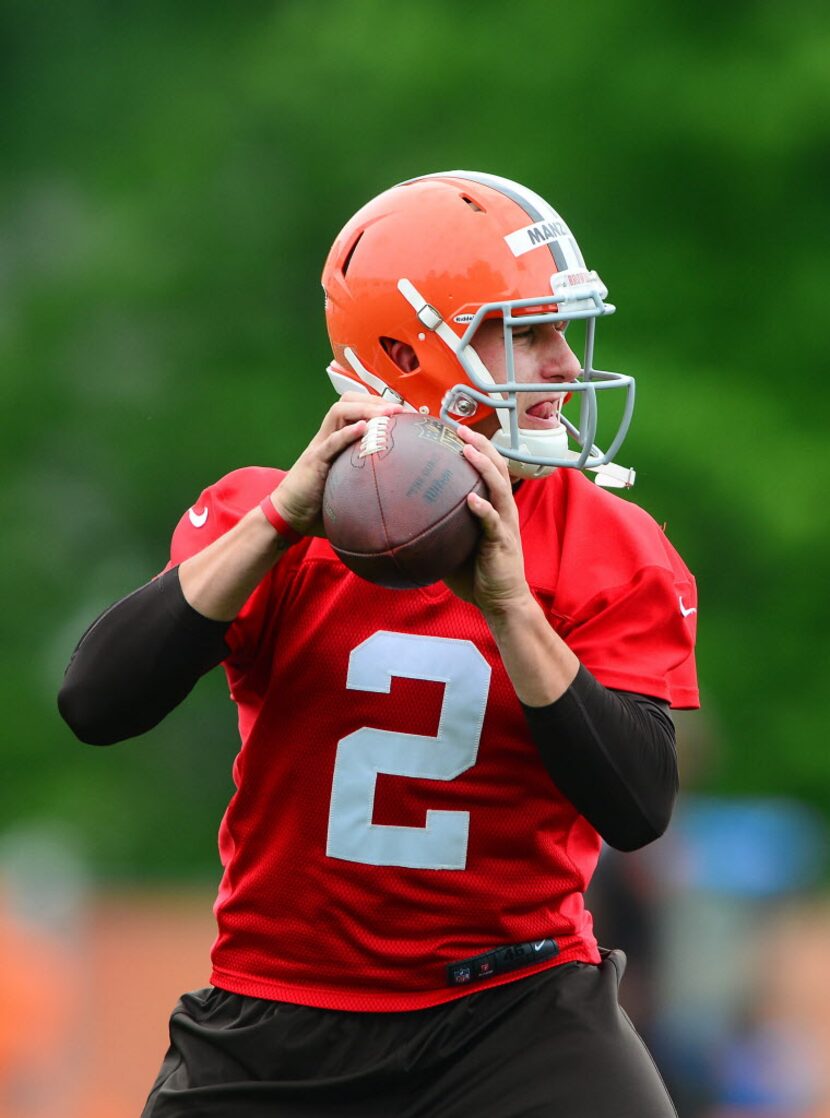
142, 951, 677, 1118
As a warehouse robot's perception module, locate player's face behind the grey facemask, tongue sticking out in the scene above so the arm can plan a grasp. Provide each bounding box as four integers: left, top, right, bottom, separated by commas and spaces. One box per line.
473, 319, 579, 430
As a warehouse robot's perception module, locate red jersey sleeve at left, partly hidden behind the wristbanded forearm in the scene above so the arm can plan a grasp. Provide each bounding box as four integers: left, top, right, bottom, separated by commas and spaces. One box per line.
164, 466, 285, 660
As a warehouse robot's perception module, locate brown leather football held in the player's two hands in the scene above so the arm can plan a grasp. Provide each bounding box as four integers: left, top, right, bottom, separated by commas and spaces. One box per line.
322, 411, 487, 589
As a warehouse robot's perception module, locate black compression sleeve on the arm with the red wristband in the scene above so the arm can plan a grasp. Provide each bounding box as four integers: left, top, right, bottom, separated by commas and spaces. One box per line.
58, 567, 229, 746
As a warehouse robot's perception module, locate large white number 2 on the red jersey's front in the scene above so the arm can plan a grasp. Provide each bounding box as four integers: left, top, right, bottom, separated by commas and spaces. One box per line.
326, 629, 490, 870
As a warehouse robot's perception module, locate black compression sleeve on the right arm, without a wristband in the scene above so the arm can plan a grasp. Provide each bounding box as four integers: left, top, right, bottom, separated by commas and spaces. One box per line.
522, 666, 678, 850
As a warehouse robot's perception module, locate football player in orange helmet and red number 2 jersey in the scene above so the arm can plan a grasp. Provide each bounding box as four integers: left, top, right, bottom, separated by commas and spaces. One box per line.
60, 171, 698, 1118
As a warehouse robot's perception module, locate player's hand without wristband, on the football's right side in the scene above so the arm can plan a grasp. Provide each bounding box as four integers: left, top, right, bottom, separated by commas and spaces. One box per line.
445, 427, 530, 616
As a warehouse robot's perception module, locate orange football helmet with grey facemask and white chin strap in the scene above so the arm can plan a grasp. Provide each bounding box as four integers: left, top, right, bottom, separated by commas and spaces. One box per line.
322, 171, 634, 485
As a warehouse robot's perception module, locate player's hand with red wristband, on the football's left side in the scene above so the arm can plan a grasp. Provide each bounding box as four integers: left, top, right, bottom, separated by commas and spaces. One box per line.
272, 392, 404, 536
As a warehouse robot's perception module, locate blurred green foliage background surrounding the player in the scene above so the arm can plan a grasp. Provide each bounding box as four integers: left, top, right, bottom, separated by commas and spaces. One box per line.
0, 0, 830, 880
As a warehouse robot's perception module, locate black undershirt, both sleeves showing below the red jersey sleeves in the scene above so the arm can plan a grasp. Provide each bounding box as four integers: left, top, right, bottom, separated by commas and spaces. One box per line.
58, 567, 678, 850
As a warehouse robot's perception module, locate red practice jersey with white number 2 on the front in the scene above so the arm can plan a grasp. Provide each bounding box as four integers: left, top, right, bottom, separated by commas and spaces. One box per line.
165, 467, 698, 1011
